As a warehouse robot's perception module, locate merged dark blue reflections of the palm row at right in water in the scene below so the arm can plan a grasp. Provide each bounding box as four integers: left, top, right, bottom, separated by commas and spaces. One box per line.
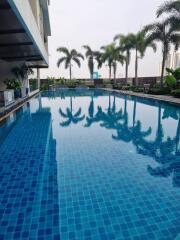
86, 95, 180, 187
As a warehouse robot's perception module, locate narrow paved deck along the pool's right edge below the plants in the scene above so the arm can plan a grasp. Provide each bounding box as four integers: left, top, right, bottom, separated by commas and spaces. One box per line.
103, 88, 180, 106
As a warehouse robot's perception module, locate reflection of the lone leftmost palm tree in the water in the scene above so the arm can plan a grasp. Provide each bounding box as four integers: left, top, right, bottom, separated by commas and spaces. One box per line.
59, 96, 85, 127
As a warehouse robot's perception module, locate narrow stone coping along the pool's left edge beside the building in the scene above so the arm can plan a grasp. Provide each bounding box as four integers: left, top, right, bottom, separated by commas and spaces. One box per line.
0, 89, 40, 123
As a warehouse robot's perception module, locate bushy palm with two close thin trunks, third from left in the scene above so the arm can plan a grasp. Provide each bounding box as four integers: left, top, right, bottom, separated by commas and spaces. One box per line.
101, 43, 125, 84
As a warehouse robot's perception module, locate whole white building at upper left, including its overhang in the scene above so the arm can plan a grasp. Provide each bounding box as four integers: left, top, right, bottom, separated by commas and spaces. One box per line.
0, 0, 51, 91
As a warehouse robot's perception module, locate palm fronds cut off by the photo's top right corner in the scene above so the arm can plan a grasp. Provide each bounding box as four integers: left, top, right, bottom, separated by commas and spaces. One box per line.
156, 0, 180, 30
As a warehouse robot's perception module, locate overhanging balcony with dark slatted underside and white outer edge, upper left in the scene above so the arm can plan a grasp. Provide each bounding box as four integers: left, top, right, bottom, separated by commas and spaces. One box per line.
0, 0, 48, 66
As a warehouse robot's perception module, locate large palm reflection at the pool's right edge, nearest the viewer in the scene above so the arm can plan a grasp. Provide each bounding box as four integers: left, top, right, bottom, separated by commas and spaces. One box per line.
138, 104, 180, 187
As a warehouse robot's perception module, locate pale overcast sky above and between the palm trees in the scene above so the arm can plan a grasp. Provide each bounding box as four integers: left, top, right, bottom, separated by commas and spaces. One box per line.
41, 0, 164, 78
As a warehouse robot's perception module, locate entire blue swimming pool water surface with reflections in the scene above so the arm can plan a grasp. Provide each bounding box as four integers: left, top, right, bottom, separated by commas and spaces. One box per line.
0, 89, 180, 240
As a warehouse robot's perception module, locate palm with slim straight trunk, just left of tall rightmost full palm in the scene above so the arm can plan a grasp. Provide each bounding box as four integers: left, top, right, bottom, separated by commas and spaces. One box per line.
131, 30, 156, 85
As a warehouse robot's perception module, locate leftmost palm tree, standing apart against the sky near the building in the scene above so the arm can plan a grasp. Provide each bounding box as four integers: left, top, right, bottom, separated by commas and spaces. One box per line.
57, 47, 84, 80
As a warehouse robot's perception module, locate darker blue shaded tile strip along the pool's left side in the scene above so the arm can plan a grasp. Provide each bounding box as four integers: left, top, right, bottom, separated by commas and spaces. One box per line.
0, 110, 60, 240
